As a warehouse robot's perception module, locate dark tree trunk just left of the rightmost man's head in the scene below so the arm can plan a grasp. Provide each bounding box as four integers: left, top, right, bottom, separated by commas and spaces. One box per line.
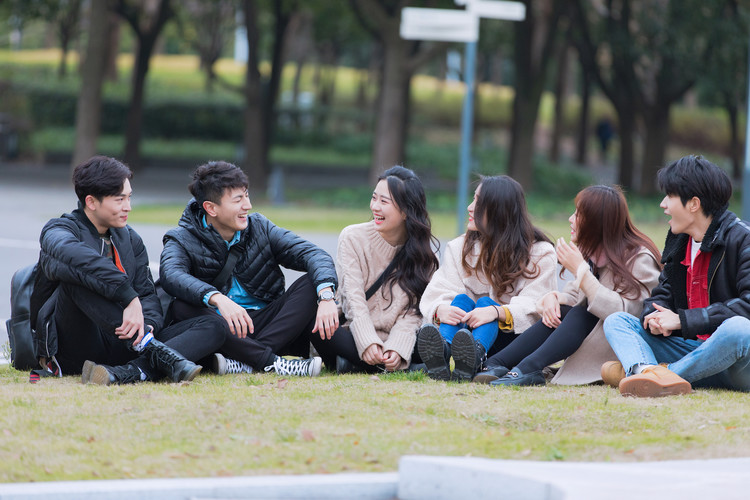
639, 103, 671, 195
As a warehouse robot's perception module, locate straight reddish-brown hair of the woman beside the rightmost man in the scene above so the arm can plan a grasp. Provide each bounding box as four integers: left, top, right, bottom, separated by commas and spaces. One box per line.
575, 186, 661, 298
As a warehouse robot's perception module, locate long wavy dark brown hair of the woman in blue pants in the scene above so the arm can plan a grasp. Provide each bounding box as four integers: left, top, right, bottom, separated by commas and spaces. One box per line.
461, 175, 551, 296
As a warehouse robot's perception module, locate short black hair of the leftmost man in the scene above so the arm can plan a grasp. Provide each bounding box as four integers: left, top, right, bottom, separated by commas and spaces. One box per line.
73, 156, 133, 205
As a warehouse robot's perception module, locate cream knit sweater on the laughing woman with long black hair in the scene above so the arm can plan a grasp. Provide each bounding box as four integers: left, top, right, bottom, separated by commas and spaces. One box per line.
336, 221, 422, 369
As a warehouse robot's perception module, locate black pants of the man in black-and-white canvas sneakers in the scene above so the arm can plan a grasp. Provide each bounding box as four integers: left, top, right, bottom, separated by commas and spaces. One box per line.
172, 275, 318, 371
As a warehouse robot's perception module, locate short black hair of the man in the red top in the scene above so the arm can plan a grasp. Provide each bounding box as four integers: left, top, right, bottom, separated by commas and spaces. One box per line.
657, 155, 732, 217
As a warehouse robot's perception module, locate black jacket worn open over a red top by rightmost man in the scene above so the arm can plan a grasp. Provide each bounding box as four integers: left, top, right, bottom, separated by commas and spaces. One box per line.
641, 211, 750, 339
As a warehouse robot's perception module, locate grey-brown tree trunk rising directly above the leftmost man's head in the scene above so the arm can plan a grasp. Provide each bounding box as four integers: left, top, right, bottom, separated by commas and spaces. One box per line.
71, 2, 109, 168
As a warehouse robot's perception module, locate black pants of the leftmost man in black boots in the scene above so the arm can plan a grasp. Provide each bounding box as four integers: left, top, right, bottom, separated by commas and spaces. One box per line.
55, 283, 226, 379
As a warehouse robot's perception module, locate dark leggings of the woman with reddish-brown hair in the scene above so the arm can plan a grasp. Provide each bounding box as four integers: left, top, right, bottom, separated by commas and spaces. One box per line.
487, 305, 599, 373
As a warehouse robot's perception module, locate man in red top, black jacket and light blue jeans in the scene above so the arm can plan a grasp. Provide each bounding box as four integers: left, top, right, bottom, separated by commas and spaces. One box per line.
602, 156, 750, 397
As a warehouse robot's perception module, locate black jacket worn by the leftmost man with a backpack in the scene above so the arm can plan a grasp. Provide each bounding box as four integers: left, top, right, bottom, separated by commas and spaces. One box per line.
39, 204, 163, 332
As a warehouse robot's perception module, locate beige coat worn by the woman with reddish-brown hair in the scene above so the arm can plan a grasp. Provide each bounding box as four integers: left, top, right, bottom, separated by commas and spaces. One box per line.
548, 247, 660, 385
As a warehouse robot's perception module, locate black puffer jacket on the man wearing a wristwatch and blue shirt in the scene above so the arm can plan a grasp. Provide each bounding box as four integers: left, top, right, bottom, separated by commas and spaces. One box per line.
159, 199, 338, 305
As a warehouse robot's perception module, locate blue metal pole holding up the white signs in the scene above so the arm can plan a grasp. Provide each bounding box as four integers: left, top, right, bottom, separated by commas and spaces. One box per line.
456, 42, 478, 234
